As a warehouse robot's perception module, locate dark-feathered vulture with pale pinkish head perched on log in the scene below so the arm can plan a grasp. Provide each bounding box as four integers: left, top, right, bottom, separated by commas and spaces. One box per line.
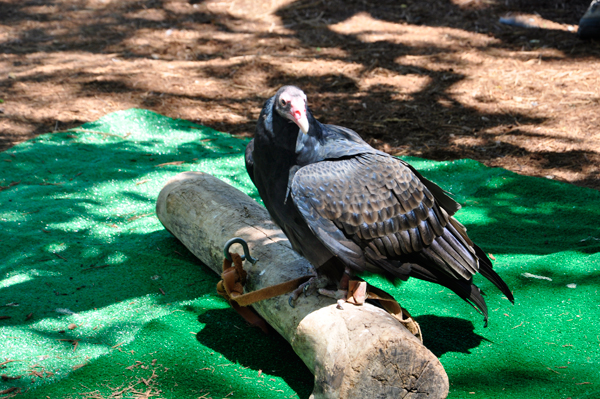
245, 86, 514, 325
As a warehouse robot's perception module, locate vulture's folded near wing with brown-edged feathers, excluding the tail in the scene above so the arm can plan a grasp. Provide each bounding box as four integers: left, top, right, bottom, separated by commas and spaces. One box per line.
292, 154, 486, 288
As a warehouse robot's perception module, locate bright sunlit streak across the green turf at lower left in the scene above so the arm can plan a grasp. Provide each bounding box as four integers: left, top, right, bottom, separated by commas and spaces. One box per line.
0, 294, 228, 387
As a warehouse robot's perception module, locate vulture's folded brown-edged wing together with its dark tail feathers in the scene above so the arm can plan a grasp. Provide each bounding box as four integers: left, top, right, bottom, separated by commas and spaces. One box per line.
292, 154, 513, 320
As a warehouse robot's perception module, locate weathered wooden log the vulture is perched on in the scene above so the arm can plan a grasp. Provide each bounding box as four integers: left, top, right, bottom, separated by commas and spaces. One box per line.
156, 172, 449, 399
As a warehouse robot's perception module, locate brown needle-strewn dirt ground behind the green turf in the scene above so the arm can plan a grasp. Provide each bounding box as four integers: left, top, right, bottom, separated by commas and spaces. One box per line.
0, 0, 600, 189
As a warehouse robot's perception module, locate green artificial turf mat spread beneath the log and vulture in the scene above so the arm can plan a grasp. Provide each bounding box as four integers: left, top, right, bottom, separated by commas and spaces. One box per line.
0, 109, 600, 399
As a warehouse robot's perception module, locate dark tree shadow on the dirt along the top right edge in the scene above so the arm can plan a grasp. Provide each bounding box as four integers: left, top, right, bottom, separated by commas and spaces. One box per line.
278, 0, 600, 58
